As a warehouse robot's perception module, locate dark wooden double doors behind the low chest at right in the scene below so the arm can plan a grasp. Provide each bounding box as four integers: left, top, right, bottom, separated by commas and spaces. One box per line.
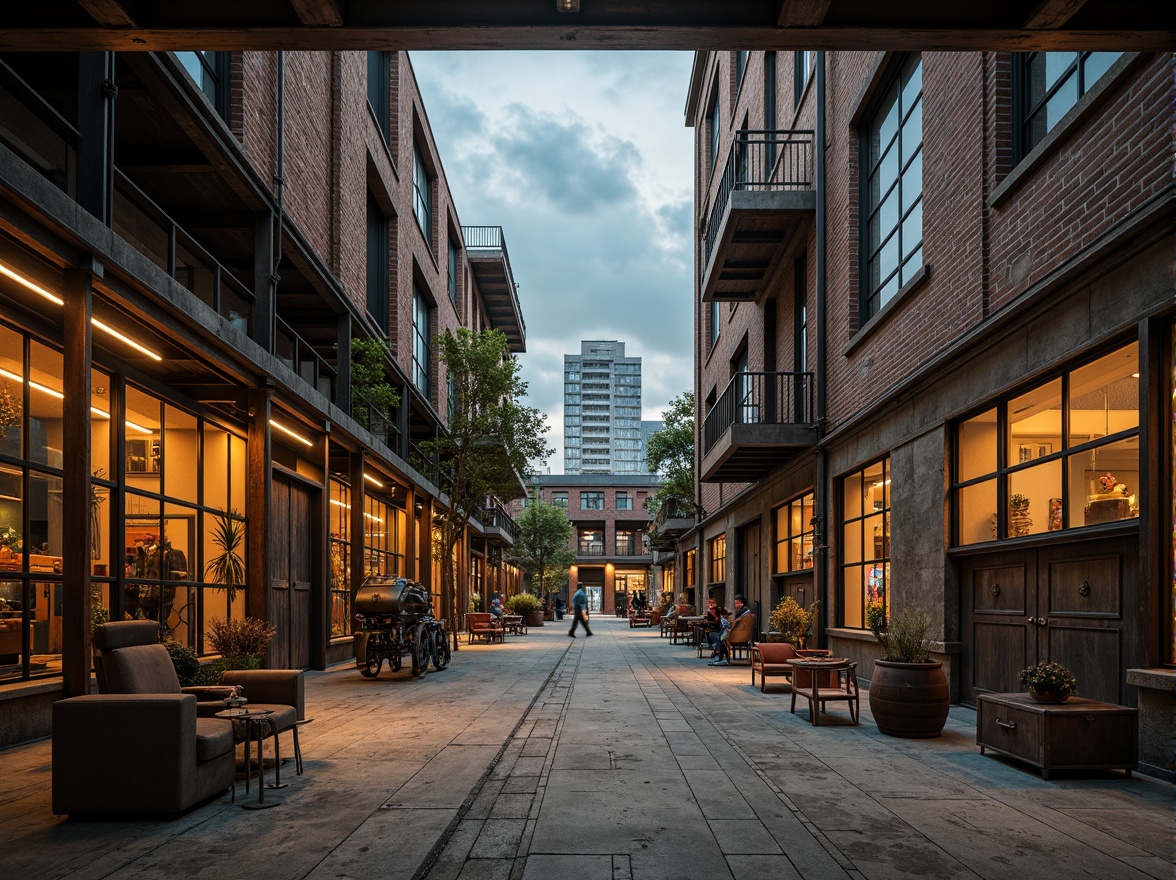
960, 531, 1138, 704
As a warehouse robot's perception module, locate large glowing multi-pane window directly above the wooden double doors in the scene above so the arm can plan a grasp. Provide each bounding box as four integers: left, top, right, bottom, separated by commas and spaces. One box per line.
954, 342, 1141, 545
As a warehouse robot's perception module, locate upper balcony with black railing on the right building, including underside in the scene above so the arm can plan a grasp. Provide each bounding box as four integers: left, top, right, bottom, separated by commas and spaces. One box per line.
702, 131, 816, 302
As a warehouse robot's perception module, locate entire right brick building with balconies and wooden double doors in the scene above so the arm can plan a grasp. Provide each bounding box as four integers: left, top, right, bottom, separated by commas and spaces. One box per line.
676, 52, 1176, 775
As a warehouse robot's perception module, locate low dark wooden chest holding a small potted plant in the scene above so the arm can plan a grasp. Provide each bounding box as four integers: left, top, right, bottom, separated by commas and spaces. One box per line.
976, 693, 1140, 779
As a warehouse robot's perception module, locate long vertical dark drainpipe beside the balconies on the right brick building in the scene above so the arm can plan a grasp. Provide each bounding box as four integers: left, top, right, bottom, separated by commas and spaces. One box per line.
813, 51, 830, 645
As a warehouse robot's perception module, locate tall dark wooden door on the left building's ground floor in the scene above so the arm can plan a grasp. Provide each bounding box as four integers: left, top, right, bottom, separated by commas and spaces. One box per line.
268, 474, 314, 669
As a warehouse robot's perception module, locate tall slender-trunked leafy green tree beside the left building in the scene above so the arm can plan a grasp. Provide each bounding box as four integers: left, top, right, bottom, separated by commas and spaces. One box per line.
419, 328, 553, 649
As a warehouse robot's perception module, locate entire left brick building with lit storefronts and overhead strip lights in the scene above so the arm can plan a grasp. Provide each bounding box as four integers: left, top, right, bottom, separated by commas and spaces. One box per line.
0, 52, 526, 744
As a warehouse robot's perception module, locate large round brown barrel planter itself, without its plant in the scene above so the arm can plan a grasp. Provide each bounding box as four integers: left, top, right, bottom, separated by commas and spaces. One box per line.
869, 660, 951, 739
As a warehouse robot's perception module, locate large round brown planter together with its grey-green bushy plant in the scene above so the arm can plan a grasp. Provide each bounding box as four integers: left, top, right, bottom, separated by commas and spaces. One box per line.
867, 599, 951, 738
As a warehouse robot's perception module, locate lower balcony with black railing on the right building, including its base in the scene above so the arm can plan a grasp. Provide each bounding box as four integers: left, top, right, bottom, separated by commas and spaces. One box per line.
701, 373, 816, 482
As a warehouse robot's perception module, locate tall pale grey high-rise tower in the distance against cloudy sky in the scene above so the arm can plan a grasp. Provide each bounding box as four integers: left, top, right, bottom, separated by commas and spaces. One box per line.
563, 340, 643, 474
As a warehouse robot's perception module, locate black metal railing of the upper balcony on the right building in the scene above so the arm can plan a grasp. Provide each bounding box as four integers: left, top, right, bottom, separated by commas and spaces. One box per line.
703, 131, 813, 265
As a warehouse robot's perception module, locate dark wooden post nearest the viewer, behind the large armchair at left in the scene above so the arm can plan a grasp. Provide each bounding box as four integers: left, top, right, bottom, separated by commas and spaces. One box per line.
61, 269, 93, 696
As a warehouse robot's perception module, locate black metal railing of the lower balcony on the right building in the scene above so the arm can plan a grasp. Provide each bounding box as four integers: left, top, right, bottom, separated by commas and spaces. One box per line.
702, 373, 813, 454
